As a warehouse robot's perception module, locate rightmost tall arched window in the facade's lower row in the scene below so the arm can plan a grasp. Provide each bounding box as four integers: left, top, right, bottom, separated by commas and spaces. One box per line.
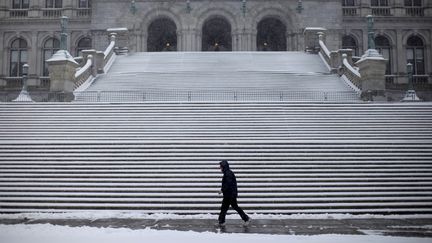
406, 36, 426, 74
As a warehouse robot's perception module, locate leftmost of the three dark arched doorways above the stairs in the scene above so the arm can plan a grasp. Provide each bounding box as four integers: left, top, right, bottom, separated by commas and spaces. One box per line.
147, 18, 177, 52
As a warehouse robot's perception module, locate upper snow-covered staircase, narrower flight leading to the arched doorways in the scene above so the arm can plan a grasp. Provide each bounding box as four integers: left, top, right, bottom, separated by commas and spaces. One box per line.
76, 52, 359, 102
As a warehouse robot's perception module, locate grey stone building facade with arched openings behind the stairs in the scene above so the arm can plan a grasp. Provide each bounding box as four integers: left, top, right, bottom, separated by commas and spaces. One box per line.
0, 0, 432, 90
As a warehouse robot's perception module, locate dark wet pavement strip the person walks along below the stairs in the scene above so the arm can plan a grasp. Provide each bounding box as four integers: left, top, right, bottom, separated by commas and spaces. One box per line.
0, 218, 432, 237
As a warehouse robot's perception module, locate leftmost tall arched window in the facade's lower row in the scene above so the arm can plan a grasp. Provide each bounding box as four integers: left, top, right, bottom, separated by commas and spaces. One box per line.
9, 38, 27, 77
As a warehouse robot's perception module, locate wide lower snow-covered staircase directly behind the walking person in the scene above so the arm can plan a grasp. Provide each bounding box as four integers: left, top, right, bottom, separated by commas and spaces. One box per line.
0, 103, 432, 214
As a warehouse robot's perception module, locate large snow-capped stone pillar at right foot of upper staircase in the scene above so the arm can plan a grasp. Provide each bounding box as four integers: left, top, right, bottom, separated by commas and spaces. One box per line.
356, 56, 387, 100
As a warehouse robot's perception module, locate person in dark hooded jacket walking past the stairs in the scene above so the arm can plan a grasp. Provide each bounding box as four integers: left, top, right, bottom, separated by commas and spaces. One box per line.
218, 160, 250, 226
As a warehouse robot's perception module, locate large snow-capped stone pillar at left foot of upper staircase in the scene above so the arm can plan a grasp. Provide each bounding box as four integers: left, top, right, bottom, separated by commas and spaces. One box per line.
47, 50, 79, 101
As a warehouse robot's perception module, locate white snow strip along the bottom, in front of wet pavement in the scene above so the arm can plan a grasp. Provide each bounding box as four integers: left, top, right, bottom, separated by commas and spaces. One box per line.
0, 224, 431, 243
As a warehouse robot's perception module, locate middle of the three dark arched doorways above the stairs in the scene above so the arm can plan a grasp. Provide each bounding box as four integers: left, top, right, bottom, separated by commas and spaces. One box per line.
202, 17, 232, 51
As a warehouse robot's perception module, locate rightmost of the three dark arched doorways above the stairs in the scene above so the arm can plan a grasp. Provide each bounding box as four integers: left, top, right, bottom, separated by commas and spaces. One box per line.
257, 18, 287, 51
